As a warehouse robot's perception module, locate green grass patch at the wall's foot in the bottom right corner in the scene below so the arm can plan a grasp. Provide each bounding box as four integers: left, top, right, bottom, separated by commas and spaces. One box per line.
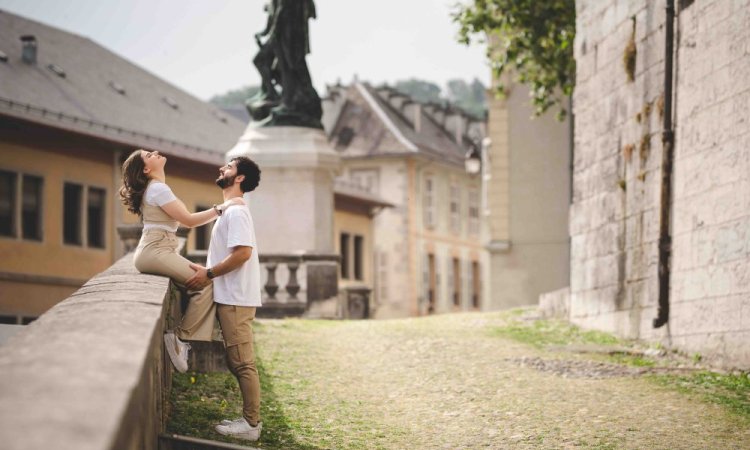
650, 371, 750, 420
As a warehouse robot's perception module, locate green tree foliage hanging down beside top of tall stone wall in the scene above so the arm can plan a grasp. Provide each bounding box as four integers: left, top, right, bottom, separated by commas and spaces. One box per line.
453, 0, 575, 118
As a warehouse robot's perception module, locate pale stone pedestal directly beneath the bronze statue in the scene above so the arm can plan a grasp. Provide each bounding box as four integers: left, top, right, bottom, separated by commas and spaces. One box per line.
226, 124, 339, 254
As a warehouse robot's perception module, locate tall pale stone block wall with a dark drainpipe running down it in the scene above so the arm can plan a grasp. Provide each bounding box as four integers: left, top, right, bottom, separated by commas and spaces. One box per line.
570, 0, 750, 367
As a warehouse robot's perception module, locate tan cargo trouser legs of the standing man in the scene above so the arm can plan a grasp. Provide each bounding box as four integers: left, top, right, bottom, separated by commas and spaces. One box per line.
217, 304, 260, 427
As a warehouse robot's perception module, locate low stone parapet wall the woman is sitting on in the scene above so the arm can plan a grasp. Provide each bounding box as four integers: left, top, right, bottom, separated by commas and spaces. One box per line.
0, 253, 179, 450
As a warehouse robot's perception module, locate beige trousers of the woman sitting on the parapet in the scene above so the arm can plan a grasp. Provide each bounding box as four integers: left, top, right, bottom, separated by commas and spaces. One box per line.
134, 229, 216, 342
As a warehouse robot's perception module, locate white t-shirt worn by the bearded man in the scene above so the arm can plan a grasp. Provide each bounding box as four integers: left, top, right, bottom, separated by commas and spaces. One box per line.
207, 205, 261, 307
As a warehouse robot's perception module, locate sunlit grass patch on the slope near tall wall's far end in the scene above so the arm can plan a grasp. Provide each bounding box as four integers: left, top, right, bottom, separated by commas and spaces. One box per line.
492, 320, 620, 348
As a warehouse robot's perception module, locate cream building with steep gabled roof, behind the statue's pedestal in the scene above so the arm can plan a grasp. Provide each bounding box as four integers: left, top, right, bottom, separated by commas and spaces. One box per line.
323, 82, 488, 318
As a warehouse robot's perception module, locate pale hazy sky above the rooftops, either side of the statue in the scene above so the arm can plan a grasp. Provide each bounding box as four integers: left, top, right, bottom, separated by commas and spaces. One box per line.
0, 0, 490, 99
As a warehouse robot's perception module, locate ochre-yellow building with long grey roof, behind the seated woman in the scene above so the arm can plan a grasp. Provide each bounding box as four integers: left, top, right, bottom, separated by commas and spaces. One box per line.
0, 11, 244, 323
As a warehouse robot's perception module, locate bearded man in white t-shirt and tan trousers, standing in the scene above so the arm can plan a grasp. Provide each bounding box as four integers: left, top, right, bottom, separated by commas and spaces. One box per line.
185, 157, 262, 441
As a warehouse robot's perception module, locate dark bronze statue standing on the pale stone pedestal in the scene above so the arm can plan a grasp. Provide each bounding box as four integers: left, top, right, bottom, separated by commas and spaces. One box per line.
246, 0, 323, 128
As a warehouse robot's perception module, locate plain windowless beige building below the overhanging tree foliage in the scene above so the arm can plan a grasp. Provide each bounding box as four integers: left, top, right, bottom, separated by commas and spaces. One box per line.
483, 76, 573, 309
